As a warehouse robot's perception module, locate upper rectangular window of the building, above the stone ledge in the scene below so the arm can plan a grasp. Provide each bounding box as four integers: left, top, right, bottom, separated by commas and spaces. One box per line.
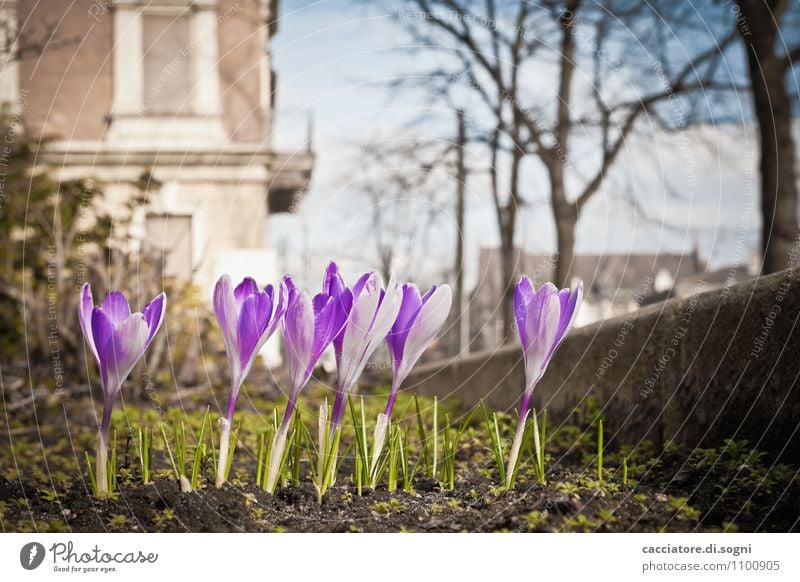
142, 13, 193, 114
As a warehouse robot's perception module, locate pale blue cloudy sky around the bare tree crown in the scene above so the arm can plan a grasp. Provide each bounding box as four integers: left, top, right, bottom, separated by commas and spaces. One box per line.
270, 0, 758, 290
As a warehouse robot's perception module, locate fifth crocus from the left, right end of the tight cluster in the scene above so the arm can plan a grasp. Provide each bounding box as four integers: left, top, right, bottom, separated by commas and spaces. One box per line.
370, 283, 453, 487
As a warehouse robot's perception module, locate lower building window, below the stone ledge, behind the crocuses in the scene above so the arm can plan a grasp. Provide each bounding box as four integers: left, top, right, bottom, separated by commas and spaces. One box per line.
144, 214, 193, 281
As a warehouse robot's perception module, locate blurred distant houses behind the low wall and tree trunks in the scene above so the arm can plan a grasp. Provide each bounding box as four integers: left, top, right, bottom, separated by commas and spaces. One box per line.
469, 248, 720, 351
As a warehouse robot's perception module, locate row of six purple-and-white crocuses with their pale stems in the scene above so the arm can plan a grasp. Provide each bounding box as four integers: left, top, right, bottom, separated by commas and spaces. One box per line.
79, 263, 582, 494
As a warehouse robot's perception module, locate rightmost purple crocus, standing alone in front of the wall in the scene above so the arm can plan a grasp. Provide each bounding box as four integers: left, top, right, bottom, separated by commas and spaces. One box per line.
506, 275, 583, 486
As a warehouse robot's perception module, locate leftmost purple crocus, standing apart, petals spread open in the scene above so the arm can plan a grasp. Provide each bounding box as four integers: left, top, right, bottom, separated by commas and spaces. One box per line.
78, 283, 167, 493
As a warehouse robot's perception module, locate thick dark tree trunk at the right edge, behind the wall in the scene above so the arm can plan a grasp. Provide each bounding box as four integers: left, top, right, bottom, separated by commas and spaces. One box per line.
739, 0, 798, 274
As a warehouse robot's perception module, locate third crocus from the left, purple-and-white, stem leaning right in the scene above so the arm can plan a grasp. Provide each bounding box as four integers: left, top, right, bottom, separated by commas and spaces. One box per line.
267, 263, 353, 493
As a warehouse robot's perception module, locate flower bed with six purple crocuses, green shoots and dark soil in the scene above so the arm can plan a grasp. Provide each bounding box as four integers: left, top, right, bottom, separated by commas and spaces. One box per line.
0, 263, 798, 531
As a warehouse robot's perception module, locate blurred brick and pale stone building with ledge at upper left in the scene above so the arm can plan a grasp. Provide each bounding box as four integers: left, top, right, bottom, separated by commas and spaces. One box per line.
0, 0, 313, 292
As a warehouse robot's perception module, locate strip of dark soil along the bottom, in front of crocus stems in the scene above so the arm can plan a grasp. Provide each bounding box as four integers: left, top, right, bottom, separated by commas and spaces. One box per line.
0, 457, 800, 532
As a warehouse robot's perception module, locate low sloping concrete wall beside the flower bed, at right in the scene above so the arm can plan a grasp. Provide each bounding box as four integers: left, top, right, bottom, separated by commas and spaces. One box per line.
406, 271, 800, 460
